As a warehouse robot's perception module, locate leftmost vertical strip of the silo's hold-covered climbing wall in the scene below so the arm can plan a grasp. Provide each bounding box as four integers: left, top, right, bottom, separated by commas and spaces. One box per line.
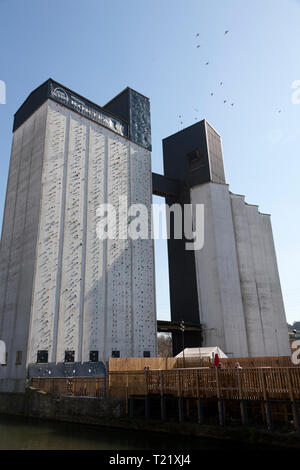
29, 102, 69, 362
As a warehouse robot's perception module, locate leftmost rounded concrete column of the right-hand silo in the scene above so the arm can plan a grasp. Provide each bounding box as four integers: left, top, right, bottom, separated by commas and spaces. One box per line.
191, 183, 248, 357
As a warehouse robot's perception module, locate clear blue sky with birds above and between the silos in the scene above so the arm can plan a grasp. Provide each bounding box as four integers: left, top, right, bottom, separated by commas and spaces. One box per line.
0, 0, 300, 322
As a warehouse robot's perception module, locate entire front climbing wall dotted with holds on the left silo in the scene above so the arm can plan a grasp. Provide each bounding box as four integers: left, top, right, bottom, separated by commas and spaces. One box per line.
28, 101, 156, 363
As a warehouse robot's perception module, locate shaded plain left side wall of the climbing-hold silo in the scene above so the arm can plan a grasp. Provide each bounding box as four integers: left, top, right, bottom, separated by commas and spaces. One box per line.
0, 105, 47, 392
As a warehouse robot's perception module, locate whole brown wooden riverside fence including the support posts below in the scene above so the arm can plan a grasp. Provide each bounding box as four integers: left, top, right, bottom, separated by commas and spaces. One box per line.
30, 367, 300, 432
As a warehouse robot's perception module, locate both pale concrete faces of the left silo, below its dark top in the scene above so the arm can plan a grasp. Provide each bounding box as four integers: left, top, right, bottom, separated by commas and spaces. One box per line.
0, 100, 157, 392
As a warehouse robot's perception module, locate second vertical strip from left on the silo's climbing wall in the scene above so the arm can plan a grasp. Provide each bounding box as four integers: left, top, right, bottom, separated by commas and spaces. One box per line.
57, 113, 89, 362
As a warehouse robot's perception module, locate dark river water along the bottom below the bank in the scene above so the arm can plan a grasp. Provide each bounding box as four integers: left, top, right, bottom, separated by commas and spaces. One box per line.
0, 415, 258, 451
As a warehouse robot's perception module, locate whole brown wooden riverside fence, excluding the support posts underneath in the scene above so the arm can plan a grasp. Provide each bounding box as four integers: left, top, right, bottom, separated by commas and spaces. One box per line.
30, 367, 300, 401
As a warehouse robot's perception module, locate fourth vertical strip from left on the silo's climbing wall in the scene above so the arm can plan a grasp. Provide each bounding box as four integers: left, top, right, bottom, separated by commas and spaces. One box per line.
106, 136, 133, 356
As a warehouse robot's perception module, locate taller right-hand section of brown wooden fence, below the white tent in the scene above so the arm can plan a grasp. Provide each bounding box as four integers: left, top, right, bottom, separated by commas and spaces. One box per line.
109, 367, 300, 401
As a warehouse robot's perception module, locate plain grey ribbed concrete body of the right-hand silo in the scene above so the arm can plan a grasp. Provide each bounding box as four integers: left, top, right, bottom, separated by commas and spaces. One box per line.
191, 183, 290, 357
